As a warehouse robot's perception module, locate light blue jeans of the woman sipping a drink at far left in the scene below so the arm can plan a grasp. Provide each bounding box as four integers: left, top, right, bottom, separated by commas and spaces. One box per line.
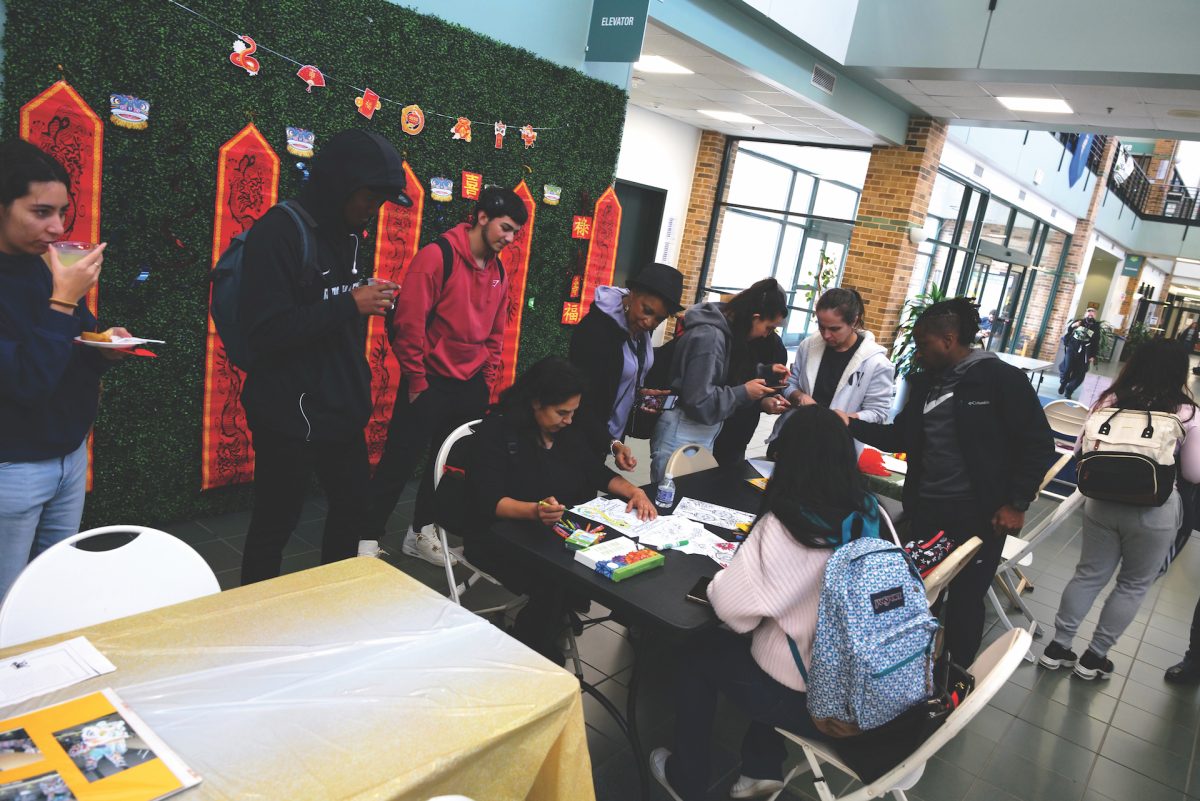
0, 439, 88, 597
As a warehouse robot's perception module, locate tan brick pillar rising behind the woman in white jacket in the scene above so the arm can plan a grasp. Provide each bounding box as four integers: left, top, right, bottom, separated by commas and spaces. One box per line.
841, 118, 946, 348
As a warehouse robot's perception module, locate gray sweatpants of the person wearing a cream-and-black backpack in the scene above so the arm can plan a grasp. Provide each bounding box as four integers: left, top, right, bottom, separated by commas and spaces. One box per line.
1054, 492, 1183, 657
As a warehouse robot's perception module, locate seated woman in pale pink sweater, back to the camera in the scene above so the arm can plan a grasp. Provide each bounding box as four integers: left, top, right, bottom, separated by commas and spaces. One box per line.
650, 405, 878, 801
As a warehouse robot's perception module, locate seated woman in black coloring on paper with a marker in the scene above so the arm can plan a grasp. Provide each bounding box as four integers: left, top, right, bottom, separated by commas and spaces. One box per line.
466, 356, 656, 664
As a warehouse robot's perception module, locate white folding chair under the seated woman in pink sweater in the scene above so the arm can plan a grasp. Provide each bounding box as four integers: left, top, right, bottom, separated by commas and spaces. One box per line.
770, 628, 1032, 801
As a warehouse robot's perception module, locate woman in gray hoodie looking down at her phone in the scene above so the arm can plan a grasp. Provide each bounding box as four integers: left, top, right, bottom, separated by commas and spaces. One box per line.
650, 278, 787, 483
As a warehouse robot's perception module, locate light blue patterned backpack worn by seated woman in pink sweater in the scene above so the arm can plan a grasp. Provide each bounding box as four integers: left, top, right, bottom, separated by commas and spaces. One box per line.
788, 527, 938, 736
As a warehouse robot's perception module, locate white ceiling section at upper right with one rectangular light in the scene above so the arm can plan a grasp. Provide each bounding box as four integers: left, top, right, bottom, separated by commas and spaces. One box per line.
877, 78, 1200, 138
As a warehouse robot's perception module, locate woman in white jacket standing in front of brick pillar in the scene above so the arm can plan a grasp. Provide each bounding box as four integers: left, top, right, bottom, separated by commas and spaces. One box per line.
767, 287, 895, 450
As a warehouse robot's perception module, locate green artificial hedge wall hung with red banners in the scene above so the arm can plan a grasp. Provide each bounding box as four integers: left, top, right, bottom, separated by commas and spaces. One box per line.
2, 0, 625, 526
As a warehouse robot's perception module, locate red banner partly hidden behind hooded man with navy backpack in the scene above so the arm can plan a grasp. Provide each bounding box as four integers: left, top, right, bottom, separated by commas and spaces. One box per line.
200, 122, 280, 489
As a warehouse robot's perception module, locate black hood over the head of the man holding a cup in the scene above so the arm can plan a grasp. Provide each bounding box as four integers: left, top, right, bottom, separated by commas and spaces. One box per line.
300, 128, 406, 233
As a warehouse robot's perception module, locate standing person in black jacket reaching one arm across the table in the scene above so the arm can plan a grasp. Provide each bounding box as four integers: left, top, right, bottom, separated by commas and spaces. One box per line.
838, 297, 1055, 664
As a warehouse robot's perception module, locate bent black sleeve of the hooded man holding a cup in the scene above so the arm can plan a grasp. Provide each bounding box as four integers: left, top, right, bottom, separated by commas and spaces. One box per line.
238, 209, 359, 359
